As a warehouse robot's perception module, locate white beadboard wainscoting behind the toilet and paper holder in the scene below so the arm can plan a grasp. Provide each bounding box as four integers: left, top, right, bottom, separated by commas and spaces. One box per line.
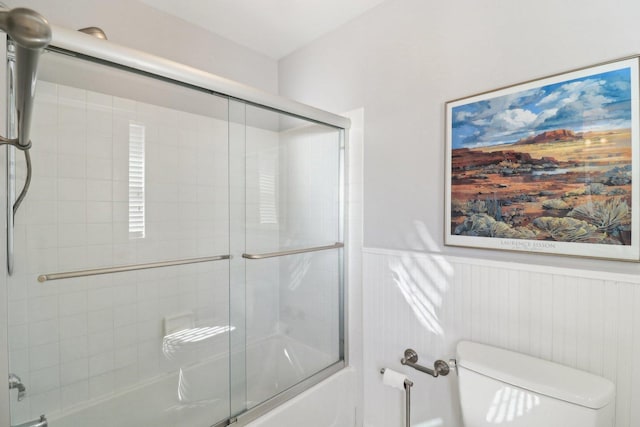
363, 248, 640, 427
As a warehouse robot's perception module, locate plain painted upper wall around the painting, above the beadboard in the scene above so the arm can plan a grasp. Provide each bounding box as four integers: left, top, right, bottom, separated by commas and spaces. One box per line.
279, 0, 640, 272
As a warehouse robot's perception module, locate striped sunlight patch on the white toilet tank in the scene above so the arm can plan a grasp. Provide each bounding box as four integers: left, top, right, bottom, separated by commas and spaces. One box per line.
486, 386, 540, 424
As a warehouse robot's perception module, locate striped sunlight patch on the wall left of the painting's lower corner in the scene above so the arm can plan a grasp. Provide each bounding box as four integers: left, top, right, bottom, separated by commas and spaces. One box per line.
389, 221, 454, 337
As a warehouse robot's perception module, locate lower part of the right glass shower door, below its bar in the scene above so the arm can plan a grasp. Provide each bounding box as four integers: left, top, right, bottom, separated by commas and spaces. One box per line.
246, 250, 341, 408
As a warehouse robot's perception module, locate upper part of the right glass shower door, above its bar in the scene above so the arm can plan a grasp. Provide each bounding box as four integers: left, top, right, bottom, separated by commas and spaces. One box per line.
246, 106, 341, 252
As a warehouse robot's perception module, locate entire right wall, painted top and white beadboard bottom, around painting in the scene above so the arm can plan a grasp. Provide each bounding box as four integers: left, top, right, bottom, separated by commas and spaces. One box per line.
279, 0, 640, 427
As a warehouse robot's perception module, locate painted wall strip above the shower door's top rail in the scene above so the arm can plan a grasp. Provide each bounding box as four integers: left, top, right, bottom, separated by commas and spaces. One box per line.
5, 0, 278, 93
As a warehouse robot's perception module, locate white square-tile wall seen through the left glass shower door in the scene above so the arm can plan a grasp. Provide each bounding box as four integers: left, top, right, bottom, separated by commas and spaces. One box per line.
8, 81, 229, 424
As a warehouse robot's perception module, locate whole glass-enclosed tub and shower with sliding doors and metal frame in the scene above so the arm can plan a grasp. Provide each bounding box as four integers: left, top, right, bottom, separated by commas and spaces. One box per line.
1, 9, 349, 427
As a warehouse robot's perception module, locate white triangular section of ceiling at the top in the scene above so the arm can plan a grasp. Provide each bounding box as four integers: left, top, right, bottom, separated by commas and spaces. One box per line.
140, 0, 384, 59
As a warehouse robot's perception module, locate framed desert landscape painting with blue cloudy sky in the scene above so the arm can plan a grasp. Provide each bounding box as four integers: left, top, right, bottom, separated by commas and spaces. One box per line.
445, 57, 640, 261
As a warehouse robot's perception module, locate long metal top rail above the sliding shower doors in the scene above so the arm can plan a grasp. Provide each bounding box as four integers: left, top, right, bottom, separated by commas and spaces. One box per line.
51, 25, 351, 129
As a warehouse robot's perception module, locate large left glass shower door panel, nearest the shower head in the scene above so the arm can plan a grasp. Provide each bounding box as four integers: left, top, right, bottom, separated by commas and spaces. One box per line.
9, 52, 230, 427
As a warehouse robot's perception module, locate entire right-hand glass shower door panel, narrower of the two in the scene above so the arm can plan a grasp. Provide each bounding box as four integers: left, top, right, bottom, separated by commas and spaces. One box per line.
245, 106, 342, 408
